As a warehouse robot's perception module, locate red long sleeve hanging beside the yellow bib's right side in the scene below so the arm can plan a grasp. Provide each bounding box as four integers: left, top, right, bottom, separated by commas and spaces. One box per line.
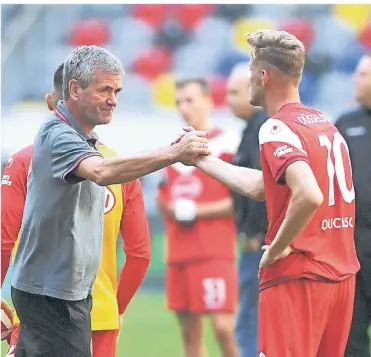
117, 180, 151, 314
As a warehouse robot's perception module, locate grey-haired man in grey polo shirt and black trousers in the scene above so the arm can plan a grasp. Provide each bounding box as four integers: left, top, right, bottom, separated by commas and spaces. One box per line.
12, 46, 209, 357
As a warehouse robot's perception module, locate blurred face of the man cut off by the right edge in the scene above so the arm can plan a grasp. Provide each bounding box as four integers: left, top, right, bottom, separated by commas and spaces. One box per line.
354, 56, 371, 105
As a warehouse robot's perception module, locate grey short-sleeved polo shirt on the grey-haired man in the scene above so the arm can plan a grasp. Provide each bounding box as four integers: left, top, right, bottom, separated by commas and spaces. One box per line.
12, 101, 104, 300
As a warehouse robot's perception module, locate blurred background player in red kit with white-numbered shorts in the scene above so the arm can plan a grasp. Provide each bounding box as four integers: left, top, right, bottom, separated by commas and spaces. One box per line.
158, 78, 239, 357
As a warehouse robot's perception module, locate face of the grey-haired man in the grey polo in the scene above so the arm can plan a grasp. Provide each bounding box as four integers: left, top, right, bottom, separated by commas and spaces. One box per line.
76, 72, 122, 126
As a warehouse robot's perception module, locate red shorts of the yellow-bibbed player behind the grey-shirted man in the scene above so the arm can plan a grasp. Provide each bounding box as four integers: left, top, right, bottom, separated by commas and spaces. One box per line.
7, 324, 118, 357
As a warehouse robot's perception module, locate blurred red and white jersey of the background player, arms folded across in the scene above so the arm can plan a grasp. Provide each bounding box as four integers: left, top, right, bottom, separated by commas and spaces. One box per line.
159, 129, 239, 262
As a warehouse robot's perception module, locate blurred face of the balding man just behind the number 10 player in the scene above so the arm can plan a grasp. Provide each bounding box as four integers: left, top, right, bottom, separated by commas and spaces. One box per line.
227, 75, 253, 119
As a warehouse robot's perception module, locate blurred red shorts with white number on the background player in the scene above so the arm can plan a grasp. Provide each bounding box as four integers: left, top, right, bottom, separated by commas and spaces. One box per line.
166, 259, 238, 313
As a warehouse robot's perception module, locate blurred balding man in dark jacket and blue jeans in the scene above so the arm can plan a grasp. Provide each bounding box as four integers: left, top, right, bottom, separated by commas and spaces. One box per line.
228, 63, 268, 357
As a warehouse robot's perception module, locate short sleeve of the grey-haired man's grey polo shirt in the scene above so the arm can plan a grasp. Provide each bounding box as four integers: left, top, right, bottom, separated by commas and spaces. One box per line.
52, 131, 101, 183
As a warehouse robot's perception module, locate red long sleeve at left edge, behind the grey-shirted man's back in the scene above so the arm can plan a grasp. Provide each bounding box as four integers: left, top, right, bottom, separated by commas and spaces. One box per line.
1, 154, 31, 285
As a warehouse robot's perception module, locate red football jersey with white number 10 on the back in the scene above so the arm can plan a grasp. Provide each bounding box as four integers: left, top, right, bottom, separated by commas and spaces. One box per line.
259, 103, 359, 289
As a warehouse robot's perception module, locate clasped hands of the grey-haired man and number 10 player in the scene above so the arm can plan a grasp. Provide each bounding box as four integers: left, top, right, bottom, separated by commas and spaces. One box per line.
170, 126, 210, 166
